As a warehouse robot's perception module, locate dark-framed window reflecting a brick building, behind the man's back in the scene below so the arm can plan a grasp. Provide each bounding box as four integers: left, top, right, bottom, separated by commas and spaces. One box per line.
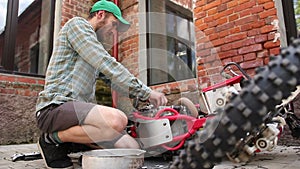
0, 0, 55, 75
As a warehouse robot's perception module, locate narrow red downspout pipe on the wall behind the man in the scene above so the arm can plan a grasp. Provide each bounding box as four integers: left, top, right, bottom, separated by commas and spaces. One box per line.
112, 0, 119, 108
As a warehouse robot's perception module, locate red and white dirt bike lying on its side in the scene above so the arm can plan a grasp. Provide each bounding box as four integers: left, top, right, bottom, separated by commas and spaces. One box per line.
128, 40, 300, 169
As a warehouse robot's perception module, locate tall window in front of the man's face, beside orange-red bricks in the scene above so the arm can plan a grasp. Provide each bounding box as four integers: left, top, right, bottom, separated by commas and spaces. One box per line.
147, 0, 196, 85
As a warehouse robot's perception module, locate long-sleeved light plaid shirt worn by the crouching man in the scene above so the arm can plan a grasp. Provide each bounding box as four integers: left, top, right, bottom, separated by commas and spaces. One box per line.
36, 17, 151, 111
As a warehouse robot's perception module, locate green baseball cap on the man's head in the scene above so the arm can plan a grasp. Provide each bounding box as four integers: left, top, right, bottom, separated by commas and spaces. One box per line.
90, 0, 130, 32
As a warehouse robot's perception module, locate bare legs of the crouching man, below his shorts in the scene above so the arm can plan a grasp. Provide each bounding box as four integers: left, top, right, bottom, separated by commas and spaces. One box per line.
58, 105, 139, 148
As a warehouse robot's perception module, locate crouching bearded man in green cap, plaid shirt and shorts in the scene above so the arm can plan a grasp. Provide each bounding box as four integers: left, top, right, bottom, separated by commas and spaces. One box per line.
36, 0, 167, 168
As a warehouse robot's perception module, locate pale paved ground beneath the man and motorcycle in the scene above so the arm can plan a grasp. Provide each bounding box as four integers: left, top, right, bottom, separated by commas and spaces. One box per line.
0, 144, 300, 169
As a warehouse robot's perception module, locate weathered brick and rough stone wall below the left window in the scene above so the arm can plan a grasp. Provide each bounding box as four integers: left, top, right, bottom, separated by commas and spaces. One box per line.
0, 73, 44, 144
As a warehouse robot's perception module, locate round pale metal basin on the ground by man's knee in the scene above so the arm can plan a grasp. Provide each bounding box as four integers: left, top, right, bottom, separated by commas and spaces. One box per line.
82, 149, 146, 169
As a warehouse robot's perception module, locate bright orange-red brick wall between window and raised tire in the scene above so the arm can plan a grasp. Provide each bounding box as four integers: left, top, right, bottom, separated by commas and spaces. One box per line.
194, 0, 280, 87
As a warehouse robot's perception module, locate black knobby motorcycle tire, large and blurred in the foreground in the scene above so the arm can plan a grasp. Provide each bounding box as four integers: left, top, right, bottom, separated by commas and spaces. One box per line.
170, 39, 300, 169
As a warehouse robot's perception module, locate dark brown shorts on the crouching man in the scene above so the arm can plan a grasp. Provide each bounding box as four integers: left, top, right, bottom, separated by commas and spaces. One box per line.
36, 101, 96, 133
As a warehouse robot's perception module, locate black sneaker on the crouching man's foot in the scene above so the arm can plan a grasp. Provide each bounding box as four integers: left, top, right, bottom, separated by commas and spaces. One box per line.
38, 136, 73, 169
